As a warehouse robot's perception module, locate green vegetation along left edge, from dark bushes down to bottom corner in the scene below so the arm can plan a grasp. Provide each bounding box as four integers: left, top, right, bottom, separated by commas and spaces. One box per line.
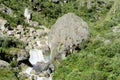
0, 37, 25, 80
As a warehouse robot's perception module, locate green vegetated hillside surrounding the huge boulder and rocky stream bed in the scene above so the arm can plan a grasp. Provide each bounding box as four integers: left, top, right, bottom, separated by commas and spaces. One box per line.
0, 0, 120, 80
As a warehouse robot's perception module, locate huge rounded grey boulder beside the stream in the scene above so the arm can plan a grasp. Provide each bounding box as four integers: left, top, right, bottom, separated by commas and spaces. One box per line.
48, 13, 89, 60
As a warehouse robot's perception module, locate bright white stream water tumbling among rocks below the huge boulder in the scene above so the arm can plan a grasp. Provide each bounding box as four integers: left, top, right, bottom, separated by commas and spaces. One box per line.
24, 49, 52, 80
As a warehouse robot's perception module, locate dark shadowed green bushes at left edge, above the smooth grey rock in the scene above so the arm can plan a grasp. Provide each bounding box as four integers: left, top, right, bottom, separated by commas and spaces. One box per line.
0, 37, 25, 62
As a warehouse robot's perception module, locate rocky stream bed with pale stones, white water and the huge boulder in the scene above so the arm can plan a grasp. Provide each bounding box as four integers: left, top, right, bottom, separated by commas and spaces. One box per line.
0, 13, 89, 80
